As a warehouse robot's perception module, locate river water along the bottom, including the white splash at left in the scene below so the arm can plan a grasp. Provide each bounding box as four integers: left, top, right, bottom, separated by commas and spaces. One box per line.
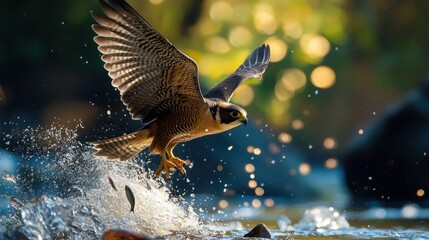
0, 126, 429, 239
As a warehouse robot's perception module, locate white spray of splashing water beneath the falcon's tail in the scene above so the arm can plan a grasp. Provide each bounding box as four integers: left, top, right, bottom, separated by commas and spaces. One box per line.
0, 126, 201, 239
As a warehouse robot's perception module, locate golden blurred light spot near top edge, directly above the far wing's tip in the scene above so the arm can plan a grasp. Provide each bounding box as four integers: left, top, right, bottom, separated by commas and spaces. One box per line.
253, 3, 277, 35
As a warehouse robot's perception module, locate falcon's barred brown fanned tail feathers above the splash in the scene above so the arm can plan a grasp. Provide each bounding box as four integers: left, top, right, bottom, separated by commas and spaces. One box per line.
89, 129, 153, 161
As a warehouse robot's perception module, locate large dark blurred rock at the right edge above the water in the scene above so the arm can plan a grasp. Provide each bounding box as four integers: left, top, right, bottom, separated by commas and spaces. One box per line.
342, 78, 429, 207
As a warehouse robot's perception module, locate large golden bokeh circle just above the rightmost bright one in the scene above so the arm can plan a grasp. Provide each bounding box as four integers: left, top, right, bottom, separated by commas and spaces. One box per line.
299, 34, 331, 60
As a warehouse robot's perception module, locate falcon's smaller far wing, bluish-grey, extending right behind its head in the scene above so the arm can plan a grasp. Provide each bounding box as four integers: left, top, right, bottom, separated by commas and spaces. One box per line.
204, 44, 270, 102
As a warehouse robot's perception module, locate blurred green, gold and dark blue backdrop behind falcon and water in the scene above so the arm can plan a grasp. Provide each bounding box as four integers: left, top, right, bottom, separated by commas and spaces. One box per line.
0, 0, 429, 210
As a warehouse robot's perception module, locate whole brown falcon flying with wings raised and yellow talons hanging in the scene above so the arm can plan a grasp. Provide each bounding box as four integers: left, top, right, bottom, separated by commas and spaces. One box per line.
90, 0, 270, 179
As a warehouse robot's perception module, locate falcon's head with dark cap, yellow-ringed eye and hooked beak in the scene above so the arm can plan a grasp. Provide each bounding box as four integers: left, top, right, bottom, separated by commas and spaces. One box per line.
211, 102, 247, 129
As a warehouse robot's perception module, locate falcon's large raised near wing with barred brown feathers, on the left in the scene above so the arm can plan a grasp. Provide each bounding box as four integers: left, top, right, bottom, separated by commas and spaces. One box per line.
91, 0, 204, 123
